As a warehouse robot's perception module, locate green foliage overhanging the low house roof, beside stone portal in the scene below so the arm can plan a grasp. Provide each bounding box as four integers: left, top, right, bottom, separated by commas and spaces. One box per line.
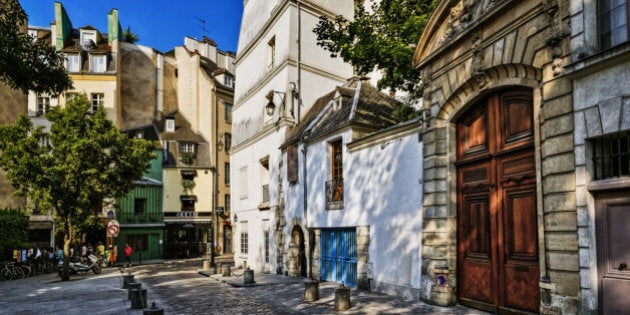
313, 0, 438, 99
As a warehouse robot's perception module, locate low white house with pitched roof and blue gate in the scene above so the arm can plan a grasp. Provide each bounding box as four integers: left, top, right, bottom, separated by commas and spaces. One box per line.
282, 79, 422, 299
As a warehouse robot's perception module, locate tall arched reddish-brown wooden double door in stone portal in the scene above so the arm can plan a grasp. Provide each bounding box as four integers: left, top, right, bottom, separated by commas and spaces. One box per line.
457, 89, 540, 313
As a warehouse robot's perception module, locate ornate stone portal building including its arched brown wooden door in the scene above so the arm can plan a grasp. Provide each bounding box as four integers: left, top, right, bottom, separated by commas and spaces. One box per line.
414, 0, 594, 314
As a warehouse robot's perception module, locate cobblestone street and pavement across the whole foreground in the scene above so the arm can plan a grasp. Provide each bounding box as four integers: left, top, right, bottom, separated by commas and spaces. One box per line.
0, 259, 485, 315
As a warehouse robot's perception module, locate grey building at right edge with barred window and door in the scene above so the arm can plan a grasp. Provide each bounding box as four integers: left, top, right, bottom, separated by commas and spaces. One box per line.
572, 1, 630, 314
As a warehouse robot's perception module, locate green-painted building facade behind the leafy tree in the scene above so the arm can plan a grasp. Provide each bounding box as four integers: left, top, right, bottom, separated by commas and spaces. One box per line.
115, 150, 164, 264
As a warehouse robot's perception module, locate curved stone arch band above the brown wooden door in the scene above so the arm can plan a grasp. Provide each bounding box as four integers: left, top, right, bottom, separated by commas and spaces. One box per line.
435, 64, 542, 127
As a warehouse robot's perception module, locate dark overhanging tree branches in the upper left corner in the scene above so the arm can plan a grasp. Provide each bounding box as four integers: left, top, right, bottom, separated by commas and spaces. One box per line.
0, 0, 72, 95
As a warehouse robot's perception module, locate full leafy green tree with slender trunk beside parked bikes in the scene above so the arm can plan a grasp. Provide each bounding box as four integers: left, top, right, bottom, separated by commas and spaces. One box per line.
0, 95, 155, 280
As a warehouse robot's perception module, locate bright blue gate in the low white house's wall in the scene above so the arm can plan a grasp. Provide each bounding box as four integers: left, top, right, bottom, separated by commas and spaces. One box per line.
321, 228, 357, 286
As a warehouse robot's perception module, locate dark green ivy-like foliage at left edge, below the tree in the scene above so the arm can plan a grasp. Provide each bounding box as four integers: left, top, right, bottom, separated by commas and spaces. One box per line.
0, 209, 28, 260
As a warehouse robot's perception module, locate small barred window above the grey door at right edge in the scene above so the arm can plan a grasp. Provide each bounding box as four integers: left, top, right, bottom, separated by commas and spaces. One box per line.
591, 132, 630, 180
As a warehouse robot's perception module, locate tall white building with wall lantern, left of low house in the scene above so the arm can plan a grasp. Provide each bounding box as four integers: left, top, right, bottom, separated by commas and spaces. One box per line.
230, 0, 354, 273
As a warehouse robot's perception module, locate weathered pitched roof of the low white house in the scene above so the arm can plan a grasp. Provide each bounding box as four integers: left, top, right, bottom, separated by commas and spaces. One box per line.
282, 79, 399, 147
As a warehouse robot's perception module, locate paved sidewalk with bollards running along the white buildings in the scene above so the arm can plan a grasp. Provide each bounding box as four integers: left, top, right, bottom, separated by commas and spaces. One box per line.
198, 269, 489, 314
